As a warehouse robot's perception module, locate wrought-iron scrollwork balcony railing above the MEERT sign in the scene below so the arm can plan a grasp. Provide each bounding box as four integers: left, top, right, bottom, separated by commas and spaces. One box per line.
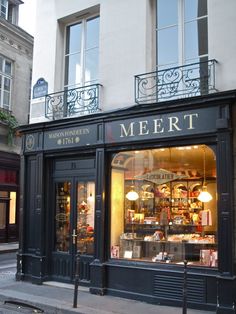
135, 60, 216, 104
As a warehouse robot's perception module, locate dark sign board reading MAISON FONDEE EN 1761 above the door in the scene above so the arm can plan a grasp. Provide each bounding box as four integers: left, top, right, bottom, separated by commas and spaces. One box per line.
43, 124, 97, 150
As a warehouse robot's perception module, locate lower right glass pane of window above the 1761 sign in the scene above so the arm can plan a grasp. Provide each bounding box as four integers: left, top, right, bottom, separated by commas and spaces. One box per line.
85, 49, 98, 83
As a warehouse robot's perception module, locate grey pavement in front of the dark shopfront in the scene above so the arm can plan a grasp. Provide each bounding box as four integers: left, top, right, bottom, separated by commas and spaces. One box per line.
0, 273, 213, 314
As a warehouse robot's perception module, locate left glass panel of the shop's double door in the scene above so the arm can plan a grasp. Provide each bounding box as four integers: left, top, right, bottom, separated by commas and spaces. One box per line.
55, 181, 71, 252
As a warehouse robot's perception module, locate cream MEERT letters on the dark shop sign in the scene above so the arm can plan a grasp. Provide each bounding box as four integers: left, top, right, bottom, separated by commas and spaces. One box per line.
120, 113, 198, 137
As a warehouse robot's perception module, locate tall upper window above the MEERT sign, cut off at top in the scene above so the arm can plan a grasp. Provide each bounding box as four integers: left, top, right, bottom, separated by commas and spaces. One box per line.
157, 0, 208, 69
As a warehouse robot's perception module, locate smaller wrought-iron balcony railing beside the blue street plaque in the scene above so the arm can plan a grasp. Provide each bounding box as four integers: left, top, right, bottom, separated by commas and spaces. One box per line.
45, 84, 101, 120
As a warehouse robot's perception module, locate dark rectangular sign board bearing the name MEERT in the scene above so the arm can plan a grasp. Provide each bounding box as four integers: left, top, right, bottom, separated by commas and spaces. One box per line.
105, 107, 218, 143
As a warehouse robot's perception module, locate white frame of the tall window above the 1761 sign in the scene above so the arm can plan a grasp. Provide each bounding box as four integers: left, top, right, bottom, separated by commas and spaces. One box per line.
64, 14, 100, 89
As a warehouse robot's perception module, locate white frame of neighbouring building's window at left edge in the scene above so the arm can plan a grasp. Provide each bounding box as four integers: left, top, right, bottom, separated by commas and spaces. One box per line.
0, 55, 13, 111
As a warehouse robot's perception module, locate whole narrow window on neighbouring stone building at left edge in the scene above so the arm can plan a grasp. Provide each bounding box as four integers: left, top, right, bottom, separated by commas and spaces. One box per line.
0, 56, 12, 110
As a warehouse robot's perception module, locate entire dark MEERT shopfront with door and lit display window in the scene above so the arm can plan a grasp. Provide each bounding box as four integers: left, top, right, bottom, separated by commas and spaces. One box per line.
16, 91, 236, 313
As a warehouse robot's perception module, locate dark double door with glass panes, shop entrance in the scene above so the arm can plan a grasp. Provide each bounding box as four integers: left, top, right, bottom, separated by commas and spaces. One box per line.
52, 176, 95, 284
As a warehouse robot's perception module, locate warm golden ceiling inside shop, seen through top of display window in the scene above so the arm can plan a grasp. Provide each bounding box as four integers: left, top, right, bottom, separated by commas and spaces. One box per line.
113, 145, 216, 177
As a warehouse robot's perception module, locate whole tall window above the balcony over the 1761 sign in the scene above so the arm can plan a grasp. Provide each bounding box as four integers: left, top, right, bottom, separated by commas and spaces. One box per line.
65, 17, 99, 88
